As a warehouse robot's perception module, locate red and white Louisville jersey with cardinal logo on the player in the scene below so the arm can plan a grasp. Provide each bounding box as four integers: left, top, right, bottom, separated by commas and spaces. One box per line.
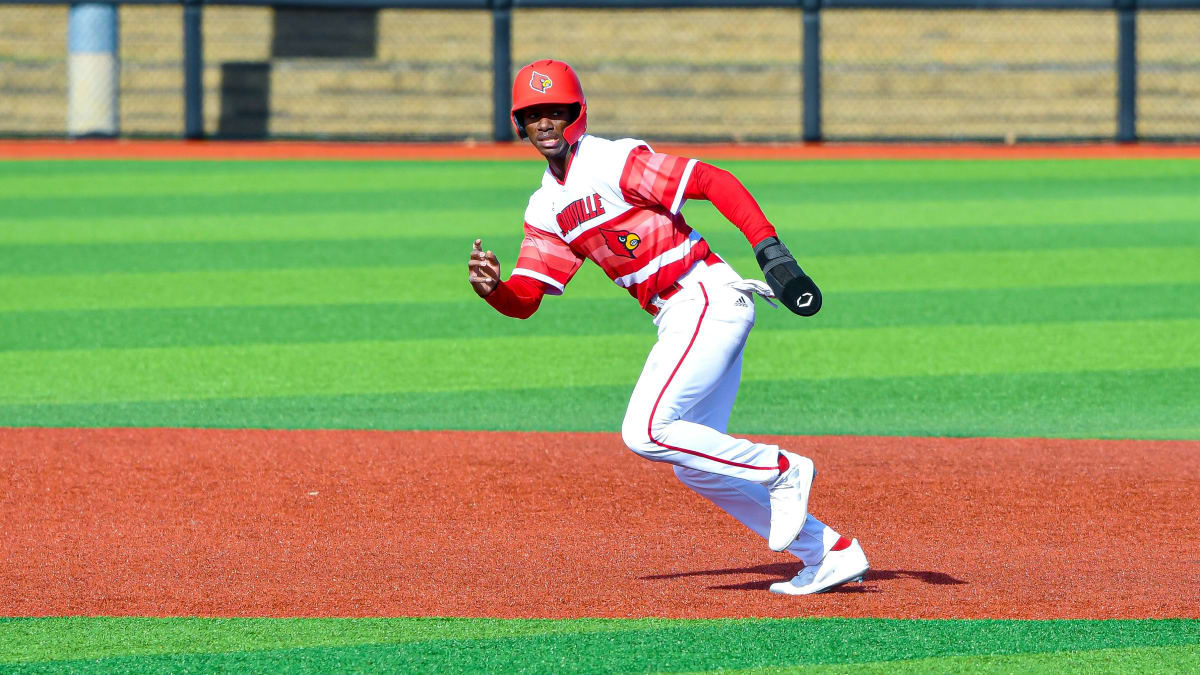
512, 136, 709, 311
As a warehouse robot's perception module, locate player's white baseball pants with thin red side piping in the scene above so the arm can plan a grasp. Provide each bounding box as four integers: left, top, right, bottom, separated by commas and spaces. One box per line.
622, 263, 839, 565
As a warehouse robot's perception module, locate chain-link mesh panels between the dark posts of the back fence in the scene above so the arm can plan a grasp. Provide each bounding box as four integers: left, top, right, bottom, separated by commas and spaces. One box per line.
0, 4, 1200, 142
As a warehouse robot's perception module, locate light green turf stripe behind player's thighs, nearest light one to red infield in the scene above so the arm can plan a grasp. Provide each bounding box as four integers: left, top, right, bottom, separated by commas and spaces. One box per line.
0, 319, 1200, 404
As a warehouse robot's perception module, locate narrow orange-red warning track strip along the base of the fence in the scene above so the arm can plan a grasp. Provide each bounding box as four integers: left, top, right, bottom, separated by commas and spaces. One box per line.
7, 139, 1200, 161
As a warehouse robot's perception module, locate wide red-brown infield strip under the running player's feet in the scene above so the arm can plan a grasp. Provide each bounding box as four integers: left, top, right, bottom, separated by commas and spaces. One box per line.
0, 429, 1200, 619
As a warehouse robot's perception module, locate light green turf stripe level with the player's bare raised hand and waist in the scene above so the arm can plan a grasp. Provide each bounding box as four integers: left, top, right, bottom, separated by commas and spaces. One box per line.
0, 246, 1200, 311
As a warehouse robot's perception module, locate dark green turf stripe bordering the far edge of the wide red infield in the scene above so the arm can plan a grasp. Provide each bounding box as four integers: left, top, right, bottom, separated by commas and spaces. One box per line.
0, 368, 1200, 440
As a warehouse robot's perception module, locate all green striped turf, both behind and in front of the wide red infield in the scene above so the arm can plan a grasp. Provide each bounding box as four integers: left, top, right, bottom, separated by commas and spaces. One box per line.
0, 160, 1200, 673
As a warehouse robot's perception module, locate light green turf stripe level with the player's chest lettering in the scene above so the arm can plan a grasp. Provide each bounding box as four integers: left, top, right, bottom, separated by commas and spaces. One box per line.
0, 192, 1200, 243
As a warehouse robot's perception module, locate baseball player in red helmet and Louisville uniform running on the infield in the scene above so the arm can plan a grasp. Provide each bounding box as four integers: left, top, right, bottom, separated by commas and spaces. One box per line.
468, 60, 868, 595
